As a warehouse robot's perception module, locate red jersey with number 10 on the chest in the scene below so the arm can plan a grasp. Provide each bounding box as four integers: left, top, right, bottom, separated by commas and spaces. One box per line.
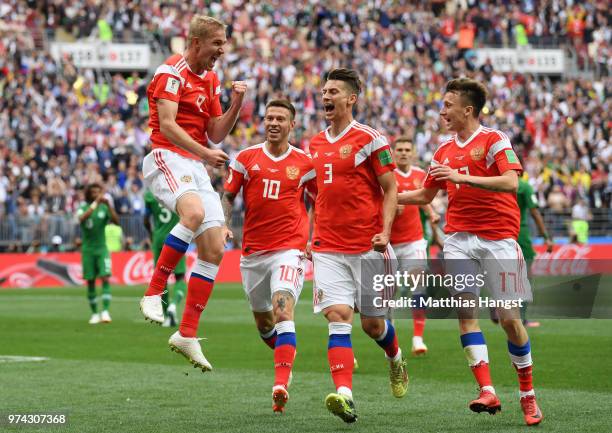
225, 143, 312, 255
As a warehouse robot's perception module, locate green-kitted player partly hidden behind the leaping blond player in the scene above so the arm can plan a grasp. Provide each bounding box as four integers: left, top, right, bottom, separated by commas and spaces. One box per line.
144, 191, 187, 327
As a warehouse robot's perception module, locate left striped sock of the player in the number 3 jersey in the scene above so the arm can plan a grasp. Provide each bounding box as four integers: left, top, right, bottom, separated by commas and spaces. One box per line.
327, 322, 355, 398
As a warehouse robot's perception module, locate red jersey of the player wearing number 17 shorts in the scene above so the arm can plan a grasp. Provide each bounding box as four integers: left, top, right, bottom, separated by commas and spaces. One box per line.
424, 126, 523, 240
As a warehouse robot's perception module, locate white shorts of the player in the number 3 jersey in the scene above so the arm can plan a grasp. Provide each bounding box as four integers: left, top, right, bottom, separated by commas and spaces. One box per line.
312, 245, 397, 317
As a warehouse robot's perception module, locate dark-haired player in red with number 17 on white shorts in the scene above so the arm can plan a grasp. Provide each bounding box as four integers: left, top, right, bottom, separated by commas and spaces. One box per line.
399, 78, 542, 425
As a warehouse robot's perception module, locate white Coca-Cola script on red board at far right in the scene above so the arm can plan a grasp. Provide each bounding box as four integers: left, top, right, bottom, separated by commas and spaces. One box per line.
531, 244, 591, 275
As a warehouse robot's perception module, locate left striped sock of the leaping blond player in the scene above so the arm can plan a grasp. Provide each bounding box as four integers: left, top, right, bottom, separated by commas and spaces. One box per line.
145, 223, 194, 296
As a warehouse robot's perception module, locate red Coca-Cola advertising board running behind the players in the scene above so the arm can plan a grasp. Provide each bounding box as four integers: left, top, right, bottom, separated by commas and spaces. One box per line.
0, 243, 612, 288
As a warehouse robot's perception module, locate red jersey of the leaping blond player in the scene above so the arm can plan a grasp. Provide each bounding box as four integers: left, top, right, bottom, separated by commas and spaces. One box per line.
147, 54, 223, 159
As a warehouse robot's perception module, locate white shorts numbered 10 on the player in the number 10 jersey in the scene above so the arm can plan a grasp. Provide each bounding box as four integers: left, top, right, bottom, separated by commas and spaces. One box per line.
240, 249, 306, 313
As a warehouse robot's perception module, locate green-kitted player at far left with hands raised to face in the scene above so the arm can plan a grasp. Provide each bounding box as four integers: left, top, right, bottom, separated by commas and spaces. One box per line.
77, 183, 119, 325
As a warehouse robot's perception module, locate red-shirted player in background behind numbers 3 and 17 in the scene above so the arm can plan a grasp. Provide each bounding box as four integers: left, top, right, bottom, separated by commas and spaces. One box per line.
391, 136, 440, 355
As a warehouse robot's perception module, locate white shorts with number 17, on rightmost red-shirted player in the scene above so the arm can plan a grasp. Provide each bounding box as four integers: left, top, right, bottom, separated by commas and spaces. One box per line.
444, 232, 533, 302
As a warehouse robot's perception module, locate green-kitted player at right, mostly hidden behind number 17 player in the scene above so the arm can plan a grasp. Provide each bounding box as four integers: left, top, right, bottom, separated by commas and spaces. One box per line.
516, 178, 553, 327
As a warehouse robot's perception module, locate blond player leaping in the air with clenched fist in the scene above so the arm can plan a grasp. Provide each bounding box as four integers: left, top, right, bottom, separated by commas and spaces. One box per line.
140, 15, 246, 371
